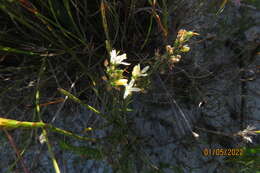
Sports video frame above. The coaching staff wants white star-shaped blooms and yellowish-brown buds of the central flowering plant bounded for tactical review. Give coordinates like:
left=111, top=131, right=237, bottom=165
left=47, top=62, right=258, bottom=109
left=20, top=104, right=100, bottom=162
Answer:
left=105, top=29, right=199, bottom=98
